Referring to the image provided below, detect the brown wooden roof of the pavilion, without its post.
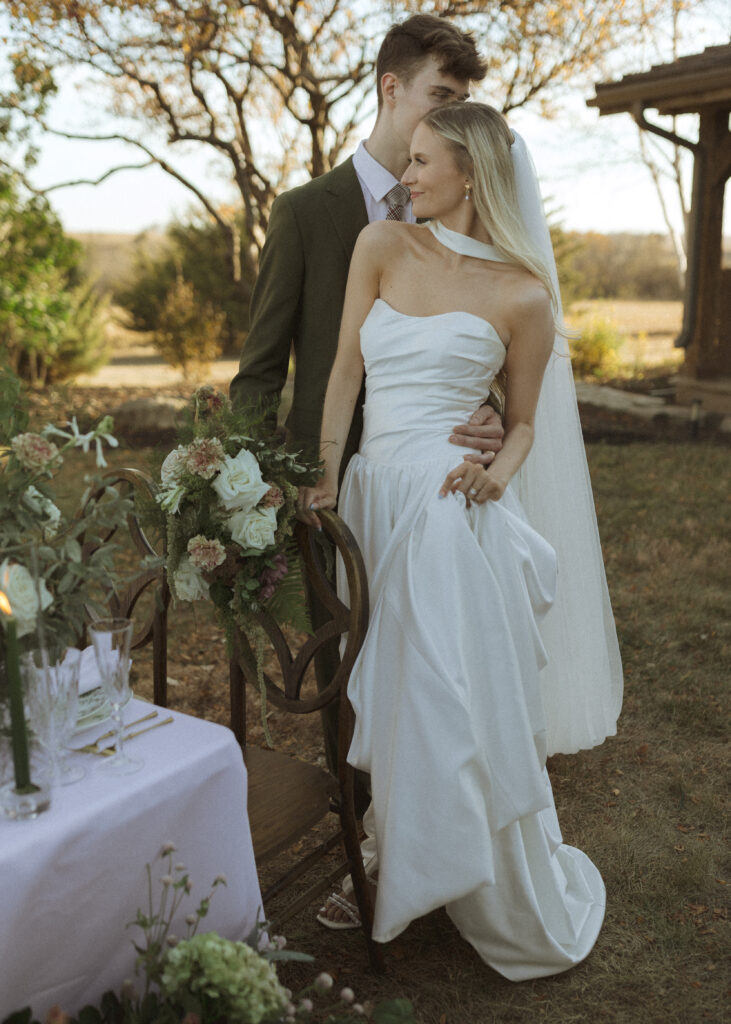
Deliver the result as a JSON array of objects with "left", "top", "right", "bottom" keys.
[{"left": 587, "top": 43, "right": 731, "bottom": 115}]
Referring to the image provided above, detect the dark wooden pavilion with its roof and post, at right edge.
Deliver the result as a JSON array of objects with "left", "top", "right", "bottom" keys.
[{"left": 587, "top": 43, "right": 731, "bottom": 412}]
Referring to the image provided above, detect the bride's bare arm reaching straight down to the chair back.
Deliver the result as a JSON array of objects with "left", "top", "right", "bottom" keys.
[{"left": 298, "top": 224, "right": 382, "bottom": 526}]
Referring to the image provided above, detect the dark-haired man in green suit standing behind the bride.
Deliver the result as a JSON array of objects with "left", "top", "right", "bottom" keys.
[{"left": 230, "top": 14, "right": 503, "bottom": 802}]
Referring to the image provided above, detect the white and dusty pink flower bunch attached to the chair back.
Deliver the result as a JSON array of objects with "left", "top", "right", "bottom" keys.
[{"left": 158, "top": 386, "right": 317, "bottom": 639}]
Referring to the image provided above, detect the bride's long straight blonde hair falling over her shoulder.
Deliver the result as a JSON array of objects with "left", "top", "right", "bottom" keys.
[{"left": 422, "top": 103, "right": 560, "bottom": 319}]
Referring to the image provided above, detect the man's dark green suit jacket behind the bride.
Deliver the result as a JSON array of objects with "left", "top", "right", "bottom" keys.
[{"left": 230, "top": 159, "right": 368, "bottom": 473}]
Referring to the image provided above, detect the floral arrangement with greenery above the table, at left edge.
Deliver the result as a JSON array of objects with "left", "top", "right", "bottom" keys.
[{"left": 0, "top": 371, "right": 130, "bottom": 664}]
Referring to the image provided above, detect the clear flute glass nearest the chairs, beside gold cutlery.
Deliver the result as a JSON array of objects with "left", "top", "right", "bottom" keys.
[{"left": 89, "top": 618, "right": 144, "bottom": 775}]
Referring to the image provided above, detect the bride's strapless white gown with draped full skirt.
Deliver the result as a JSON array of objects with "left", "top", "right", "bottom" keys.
[{"left": 339, "top": 299, "right": 605, "bottom": 981}]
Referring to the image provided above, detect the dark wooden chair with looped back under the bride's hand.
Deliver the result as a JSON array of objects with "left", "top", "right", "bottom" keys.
[{"left": 230, "top": 512, "right": 384, "bottom": 971}]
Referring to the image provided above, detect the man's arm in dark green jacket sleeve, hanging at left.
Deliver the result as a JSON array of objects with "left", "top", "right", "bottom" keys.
[{"left": 230, "top": 193, "right": 304, "bottom": 431}]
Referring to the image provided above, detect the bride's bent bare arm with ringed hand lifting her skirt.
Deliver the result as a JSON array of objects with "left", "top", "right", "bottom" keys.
[{"left": 439, "top": 282, "right": 555, "bottom": 504}]
